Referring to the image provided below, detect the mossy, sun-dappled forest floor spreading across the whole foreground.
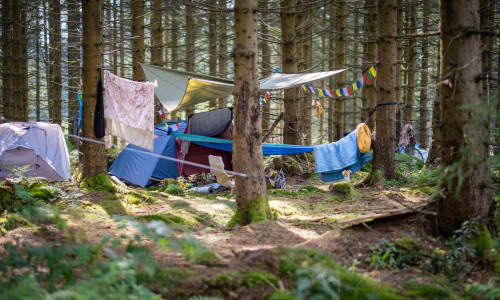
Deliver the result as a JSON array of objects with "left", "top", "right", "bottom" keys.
[{"left": 0, "top": 156, "right": 500, "bottom": 299}]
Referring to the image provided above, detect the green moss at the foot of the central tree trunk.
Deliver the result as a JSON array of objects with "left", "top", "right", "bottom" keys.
[{"left": 227, "top": 196, "right": 272, "bottom": 227}]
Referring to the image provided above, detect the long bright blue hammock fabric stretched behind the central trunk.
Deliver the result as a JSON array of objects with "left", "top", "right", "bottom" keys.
[{"left": 172, "top": 131, "right": 313, "bottom": 155}]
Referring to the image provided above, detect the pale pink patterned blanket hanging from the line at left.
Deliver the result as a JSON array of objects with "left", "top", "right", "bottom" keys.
[{"left": 104, "top": 71, "right": 154, "bottom": 151}]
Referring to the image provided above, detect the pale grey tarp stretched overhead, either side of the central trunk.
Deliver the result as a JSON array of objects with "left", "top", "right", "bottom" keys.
[{"left": 141, "top": 64, "right": 346, "bottom": 112}]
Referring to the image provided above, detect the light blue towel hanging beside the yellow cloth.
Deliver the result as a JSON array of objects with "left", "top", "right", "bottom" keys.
[{"left": 313, "top": 130, "right": 372, "bottom": 182}]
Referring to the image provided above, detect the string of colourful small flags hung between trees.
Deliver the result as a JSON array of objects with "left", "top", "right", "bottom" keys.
[{"left": 260, "top": 66, "right": 377, "bottom": 106}]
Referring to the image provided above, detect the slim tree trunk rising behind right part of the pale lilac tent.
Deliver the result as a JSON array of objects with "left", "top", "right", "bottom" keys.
[{"left": 49, "top": 0, "right": 62, "bottom": 125}]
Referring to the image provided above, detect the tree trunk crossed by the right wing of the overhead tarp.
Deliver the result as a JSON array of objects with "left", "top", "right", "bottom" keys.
[{"left": 280, "top": 0, "right": 302, "bottom": 145}]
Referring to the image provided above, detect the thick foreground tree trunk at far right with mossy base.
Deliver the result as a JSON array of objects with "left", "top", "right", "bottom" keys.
[{"left": 437, "top": 0, "right": 493, "bottom": 236}]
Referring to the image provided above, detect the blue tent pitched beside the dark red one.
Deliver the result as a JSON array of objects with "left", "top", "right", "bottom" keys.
[{"left": 109, "top": 121, "right": 187, "bottom": 187}]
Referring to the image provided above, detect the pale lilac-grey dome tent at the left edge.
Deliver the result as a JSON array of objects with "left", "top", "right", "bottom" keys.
[{"left": 0, "top": 122, "right": 71, "bottom": 180}]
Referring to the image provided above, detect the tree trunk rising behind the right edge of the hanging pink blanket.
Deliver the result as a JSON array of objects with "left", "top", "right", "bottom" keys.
[{"left": 132, "top": 0, "right": 146, "bottom": 81}]
